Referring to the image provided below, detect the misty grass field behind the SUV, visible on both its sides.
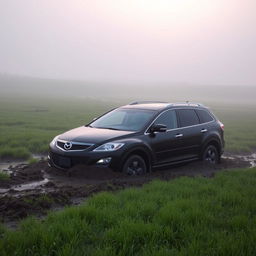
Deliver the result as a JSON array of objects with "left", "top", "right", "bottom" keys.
[{"left": 0, "top": 96, "right": 256, "bottom": 158}]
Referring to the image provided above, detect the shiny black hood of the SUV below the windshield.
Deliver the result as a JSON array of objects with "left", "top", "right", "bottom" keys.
[{"left": 58, "top": 126, "right": 134, "bottom": 144}]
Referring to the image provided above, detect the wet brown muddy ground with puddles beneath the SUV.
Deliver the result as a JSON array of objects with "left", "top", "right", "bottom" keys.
[{"left": 0, "top": 154, "right": 255, "bottom": 227}]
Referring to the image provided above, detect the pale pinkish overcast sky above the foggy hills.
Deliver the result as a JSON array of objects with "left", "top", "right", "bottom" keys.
[{"left": 0, "top": 0, "right": 256, "bottom": 86}]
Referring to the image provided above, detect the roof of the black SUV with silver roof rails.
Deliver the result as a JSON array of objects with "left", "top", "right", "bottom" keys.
[{"left": 121, "top": 101, "right": 205, "bottom": 110}]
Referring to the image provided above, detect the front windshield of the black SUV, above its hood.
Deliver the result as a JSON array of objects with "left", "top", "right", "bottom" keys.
[{"left": 89, "top": 109, "right": 155, "bottom": 131}]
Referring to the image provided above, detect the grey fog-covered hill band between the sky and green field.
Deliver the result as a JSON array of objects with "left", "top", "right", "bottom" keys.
[{"left": 0, "top": 75, "right": 256, "bottom": 109}]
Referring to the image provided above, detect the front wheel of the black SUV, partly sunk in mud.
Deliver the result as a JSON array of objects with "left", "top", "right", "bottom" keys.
[{"left": 122, "top": 155, "right": 147, "bottom": 175}]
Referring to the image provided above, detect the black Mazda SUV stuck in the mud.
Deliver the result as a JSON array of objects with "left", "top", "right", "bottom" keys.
[{"left": 48, "top": 102, "right": 224, "bottom": 174}]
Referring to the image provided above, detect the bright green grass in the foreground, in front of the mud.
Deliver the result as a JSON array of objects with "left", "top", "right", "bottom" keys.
[{"left": 0, "top": 168, "right": 256, "bottom": 256}]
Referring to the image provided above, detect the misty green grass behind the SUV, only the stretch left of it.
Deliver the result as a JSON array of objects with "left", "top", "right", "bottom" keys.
[{"left": 0, "top": 99, "right": 116, "bottom": 159}]
